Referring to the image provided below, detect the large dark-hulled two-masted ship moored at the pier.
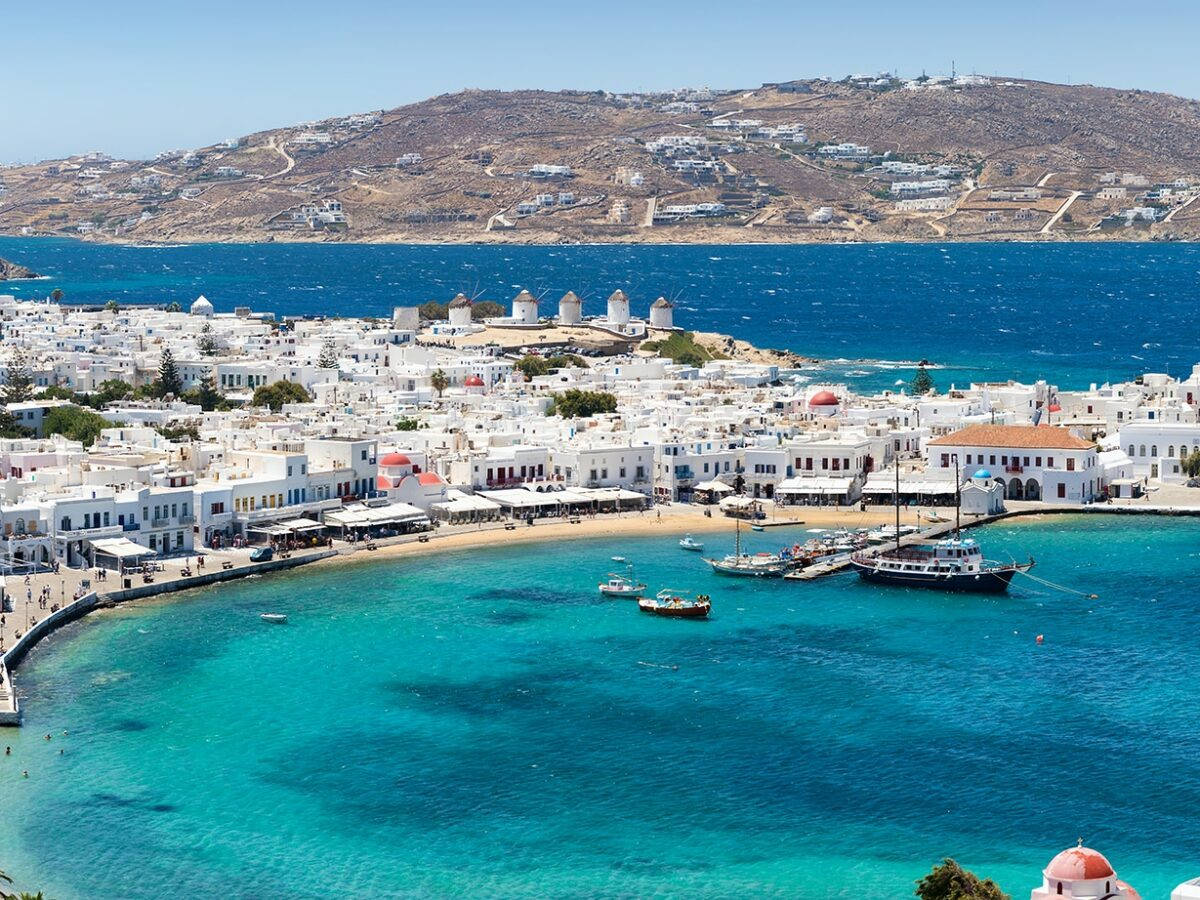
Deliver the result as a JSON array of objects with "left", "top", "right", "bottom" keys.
[{"left": 850, "top": 464, "right": 1033, "bottom": 594}]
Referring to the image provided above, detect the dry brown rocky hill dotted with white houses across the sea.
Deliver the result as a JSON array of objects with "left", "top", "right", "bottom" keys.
[{"left": 7, "top": 77, "right": 1200, "bottom": 244}]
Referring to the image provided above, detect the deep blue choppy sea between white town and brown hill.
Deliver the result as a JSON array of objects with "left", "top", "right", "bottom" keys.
[{"left": 0, "top": 238, "right": 1200, "bottom": 389}]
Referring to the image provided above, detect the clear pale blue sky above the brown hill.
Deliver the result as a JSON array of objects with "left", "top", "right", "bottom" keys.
[{"left": 9, "top": 0, "right": 1200, "bottom": 162}]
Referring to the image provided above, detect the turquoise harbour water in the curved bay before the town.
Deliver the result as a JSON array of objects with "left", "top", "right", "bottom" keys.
[{"left": 0, "top": 516, "right": 1200, "bottom": 899}]
